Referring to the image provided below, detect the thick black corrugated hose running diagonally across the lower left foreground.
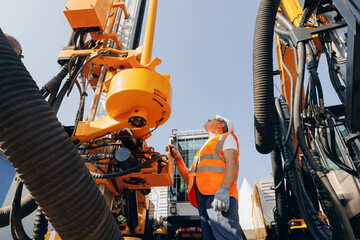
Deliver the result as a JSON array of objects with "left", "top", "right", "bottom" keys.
[{"left": 0, "top": 29, "right": 123, "bottom": 240}]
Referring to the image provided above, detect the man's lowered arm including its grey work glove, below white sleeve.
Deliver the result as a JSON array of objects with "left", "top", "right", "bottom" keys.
[{"left": 211, "top": 149, "right": 237, "bottom": 212}]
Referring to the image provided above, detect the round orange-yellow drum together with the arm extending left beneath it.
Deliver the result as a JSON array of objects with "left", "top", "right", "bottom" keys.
[{"left": 75, "top": 68, "right": 172, "bottom": 142}]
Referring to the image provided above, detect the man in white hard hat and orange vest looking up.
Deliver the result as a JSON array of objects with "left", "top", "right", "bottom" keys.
[{"left": 170, "top": 115, "right": 244, "bottom": 240}]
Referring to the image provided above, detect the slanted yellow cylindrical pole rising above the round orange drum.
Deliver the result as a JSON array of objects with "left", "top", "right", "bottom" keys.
[{"left": 141, "top": 0, "right": 158, "bottom": 65}]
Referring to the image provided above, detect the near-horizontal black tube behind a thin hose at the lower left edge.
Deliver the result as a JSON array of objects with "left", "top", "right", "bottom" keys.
[{"left": 0, "top": 194, "right": 37, "bottom": 228}]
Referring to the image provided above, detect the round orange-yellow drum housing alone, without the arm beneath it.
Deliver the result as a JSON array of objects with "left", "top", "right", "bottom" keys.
[{"left": 106, "top": 68, "right": 172, "bottom": 128}]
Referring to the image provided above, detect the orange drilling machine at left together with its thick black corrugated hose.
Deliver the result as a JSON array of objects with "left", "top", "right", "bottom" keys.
[{"left": 0, "top": 0, "right": 174, "bottom": 240}]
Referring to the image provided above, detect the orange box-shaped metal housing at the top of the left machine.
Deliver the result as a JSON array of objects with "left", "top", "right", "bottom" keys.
[{"left": 64, "top": 0, "right": 113, "bottom": 31}]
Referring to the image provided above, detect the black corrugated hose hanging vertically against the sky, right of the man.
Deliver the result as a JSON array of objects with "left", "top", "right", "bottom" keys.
[{"left": 253, "top": 0, "right": 280, "bottom": 154}]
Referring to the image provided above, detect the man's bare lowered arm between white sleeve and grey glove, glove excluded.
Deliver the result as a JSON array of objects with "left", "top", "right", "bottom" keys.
[{"left": 221, "top": 149, "right": 238, "bottom": 189}]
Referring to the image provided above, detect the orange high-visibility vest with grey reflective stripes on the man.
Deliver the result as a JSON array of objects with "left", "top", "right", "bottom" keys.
[{"left": 188, "top": 132, "right": 239, "bottom": 208}]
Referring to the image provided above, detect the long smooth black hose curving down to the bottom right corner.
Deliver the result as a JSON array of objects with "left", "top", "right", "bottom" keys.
[{"left": 294, "top": 42, "right": 355, "bottom": 240}]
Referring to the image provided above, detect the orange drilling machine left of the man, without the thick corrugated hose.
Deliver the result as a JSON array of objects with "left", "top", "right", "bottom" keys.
[{"left": 59, "top": 0, "right": 173, "bottom": 238}]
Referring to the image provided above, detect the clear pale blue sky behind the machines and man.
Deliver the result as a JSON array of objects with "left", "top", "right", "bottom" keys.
[{"left": 0, "top": 0, "right": 282, "bottom": 239}]
